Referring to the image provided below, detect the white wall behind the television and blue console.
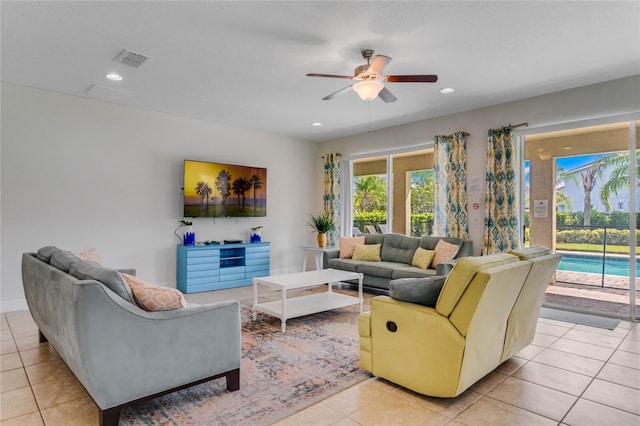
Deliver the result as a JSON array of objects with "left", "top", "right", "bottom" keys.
[{"left": 0, "top": 83, "right": 322, "bottom": 311}]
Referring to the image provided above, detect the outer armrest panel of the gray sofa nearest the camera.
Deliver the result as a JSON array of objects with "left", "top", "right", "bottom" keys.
[{"left": 69, "top": 281, "right": 241, "bottom": 409}]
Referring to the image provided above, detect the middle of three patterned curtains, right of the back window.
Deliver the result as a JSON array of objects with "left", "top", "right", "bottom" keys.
[{"left": 433, "top": 132, "right": 469, "bottom": 240}]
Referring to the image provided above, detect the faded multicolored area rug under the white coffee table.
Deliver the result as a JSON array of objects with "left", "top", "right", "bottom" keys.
[{"left": 120, "top": 288, "right": 371, "bottom": 426}]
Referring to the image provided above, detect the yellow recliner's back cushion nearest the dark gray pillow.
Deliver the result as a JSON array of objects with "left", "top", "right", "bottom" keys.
[{"left": 436, "top": 253, "right": 518, "bottom": 317}]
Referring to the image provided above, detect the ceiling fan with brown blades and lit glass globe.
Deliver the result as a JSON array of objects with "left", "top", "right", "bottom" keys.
[{"left": 307, "top": 49, "right": 438, "bottom": 103}]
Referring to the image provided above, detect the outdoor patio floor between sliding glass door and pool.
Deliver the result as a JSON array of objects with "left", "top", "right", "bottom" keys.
[{"left": 544, "top": 270, "right": 640, "bottom": 319}]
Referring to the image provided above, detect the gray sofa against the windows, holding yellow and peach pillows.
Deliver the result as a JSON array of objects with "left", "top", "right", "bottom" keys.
[{"left": 323, "top": 234, "right": 473, "bottom": 290}]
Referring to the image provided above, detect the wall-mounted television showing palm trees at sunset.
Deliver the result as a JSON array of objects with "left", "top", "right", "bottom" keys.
[{"left": 183, "top": 160, "right": 267, "bottom": 217}]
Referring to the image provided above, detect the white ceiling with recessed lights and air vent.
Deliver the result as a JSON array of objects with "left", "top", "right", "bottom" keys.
[{"left": 0, "top": 0, "right": 640, "bottom": 141}]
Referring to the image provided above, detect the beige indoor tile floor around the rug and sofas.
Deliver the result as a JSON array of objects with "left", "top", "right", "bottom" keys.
[{"left": 0, "top": 289, "right": 640, "bottom": 426}]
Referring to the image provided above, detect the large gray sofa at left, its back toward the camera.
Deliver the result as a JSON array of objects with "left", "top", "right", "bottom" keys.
[{"left": 22, "top": 251, "right": 241, "bottom": 425}]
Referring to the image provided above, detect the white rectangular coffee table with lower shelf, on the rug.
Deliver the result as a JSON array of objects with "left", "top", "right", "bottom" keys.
[{"left": 253, "top": 269, "right": 363, "bottom": 333}]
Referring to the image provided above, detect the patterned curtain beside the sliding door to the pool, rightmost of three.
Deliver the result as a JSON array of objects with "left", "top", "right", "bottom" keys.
[{"left": 482, "top": 127, "right": 520, "bottom": 256}]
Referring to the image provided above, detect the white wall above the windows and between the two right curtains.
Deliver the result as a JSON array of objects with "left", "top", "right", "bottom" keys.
[{"left": 318, "top": 75, "right": 640, "bottom": 254}]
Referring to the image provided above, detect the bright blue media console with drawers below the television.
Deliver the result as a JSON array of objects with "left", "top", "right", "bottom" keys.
[{"left": 177, "top": 242, "right": 270, "bottom": 293}]
